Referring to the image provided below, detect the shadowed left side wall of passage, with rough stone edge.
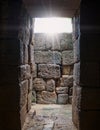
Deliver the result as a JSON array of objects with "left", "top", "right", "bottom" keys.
[{"left": 0, "top": 0, "right": 33, "bottom": 130}]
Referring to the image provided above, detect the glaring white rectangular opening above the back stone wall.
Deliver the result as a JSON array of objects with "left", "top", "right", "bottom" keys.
[{"left": 34, "top": 17, "right": 72, "bottom": 34}]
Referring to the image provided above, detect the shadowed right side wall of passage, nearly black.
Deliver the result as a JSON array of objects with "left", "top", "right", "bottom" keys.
[{"left": 72, "top": 0, "right": 100, "bottom": 130}]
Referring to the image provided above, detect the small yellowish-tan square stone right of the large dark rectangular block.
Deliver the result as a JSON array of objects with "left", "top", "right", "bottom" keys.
[{"left": 62, "top": 65, "right": 73, "bottom": 75}]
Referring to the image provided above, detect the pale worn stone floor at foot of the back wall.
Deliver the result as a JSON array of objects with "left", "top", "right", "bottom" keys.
[{"left": 23, "top": 104, "right": 76, "bottom": 130}]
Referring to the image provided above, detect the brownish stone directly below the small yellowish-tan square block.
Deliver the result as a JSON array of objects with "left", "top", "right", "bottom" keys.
[{"left": 60, "top": 75, "right": 73, "bottom": 87}]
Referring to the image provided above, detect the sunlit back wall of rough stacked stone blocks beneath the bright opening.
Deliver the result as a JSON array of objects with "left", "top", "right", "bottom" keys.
[{"left": 33, "top": 33, "right": 74, "bottom": 104}]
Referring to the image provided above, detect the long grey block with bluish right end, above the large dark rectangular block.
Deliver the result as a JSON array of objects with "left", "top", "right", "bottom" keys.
[{"left": 34, "top": 51, "right": 61, "bottom": 64}]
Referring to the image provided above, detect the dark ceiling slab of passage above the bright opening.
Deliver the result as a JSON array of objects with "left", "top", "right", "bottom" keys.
[{"left": 23, "top": 0, "right": 80, "bottom": 17}]
